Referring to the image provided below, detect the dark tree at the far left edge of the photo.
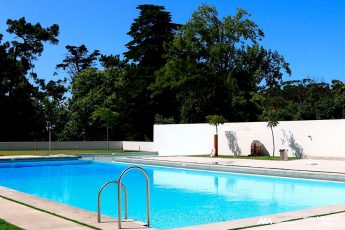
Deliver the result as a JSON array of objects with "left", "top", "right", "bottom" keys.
[{"left": 0, "top": 18, "right": 59, "bottom": 141}]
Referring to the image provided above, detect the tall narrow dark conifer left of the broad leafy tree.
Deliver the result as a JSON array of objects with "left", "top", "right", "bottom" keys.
[{"left": 124, "top": 4, "right": 179, "bottom": 139}]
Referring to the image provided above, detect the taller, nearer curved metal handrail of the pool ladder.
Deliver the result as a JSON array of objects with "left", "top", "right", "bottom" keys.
[{"left": 117, "top": 166, "right": 150, "bottom": 229}]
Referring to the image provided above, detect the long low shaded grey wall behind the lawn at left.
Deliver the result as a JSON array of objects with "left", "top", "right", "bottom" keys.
[{"left": 0, "top": 141, "right": 122, "bottom": 150}]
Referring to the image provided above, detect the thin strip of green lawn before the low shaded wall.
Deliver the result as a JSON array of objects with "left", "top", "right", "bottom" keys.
[{"left": 0, "top": 149, "right": 138, "bottom": 156}]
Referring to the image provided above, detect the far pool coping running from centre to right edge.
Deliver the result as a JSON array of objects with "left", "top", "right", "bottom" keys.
[{"left": 115, "top": 157, "right": 345, "bottom": 182}]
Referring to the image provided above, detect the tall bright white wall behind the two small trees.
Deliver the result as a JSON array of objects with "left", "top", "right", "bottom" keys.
[{"left": 154, "top": 119, "right": 345, "bottom": 157}]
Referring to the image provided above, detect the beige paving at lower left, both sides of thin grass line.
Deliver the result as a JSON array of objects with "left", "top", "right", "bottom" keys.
[{"left": 0, "top": 186, "right": 148, "bottom": 230}]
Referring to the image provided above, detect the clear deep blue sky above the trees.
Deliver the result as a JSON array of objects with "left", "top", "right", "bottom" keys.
[{"left": 0, "top": 0, "right": 345, "bottom": 82}]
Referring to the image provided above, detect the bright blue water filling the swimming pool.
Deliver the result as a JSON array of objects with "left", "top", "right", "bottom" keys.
[{"left": 0, "top": 160, "right": 345, "bottom": 229}]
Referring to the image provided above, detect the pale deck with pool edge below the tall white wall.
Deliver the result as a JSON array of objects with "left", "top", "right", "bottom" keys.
[{"left": 115, "top": 156, "right": 345, "bottom": 182}]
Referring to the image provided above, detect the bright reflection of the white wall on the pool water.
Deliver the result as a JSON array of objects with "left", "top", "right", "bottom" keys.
[{"left": 153, "top": 170, "right": 345, "bottom": 206}]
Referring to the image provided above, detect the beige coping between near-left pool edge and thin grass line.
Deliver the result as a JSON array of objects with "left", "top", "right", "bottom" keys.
[{"left": 0, "top": 186, "right": 150, "bottom": 230}]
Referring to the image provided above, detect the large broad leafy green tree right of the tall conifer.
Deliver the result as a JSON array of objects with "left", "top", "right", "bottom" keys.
[{"left": 153, "top": 5, "right": 290, "bottom": 123}]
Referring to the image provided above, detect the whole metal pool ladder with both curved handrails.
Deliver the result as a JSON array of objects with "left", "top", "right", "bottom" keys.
[{"left": 97, "top": 166, "right": 150, "bottom": 229}]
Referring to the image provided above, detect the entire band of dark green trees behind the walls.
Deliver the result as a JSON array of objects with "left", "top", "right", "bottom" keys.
[{"left": 0, "top": 4, "right": 345, "bottom": 141}]
